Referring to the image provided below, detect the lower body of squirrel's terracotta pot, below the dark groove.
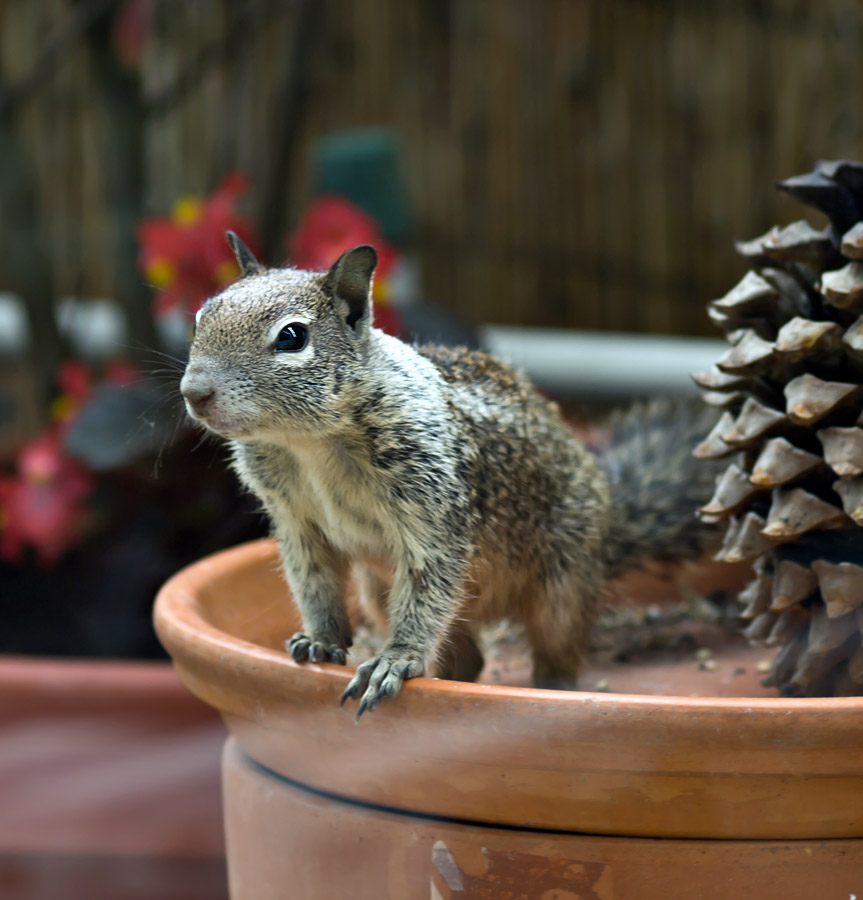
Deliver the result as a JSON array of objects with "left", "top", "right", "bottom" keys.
[{"left": 222, "top": 738, "right": 863, "bottom": 900}]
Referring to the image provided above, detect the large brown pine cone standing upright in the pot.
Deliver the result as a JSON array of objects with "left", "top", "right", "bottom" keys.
[{"left": 695, "top": 161, "right": 863, "bottom": 696}]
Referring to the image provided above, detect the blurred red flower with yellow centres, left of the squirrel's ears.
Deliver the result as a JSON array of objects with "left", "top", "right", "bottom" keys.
[{"left": 137, "top": 172, "right": 257, "bottom": 315}]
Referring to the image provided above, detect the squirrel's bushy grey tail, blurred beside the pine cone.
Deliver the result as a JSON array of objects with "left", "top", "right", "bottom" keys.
[{"left": 599, "top": 398, "right": 727, "bottom": 576}]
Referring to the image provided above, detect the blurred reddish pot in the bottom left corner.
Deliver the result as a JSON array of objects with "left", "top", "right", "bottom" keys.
[{"left": 0, "top": 656, "right": 226, "bottom": 900}]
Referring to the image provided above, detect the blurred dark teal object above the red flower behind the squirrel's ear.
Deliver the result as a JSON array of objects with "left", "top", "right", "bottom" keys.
[{"left": 311, "top": 129, "right": 410, "bottom": 245}]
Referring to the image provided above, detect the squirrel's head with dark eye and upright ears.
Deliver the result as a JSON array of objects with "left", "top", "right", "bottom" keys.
[{"left": 180, "top": 232, "right": 377, "bottom": 442}]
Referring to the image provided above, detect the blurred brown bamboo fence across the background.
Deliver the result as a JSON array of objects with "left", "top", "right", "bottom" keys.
[{"left": 0, "top": 0, "right": 863, "bottom": 341}]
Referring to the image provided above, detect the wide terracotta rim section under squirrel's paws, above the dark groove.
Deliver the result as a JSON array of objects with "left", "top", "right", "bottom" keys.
[{"left": 155, "top": 541, "right": 863, "bottom": 844}]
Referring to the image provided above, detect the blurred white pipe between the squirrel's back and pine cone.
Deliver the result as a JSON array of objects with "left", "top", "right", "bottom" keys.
[{"left": 479, "top": 325, "right": 728, "bottom": 397}]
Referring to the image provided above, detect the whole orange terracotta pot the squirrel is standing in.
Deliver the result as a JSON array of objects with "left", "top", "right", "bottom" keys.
[{"left": 156, "top": 541, "right": 863, "bottom": 900}]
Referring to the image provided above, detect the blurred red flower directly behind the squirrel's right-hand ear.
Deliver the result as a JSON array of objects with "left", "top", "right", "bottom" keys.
[{"left": 288, "top": 194, "right": 402, "bottom": 335}]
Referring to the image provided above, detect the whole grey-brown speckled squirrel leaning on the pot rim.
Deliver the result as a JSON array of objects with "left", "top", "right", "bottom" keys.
[{"left": 180, "top": 232, "right": 716, "bottom": 719}]
